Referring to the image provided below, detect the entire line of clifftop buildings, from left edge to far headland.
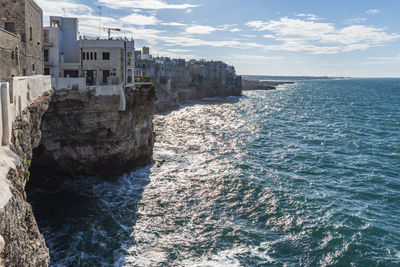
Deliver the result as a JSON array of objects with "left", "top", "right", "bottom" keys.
[{"left": 0, "top": 0, "right": 241, "bottom": 112}]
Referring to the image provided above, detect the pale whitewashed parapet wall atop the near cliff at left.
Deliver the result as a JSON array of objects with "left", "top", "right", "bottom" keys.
[{"left": 0, "top": 75, "right": 51, "bottom": 145}]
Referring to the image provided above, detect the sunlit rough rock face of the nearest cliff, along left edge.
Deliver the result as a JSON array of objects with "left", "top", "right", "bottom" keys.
[{"left": 0, "top": 93, "right": 51, "bottom": 266}]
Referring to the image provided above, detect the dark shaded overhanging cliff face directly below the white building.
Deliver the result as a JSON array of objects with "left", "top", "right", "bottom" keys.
[{"left": 32, "top": 89, "right": 154, "bottom": 178}]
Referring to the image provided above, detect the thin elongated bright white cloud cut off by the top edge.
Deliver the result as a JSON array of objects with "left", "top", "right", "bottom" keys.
[{"left": 95, "top": 0, "right": 199, "bottom": 9}]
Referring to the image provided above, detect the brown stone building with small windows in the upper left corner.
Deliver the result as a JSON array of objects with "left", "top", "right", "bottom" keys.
[{"left": 0, "top": 0, "right": 43, "bottom": 78}]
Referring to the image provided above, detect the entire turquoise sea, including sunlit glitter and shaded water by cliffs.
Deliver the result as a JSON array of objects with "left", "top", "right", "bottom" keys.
[{"left": 30, "top": 79, "right": 400, "bottom": 266}]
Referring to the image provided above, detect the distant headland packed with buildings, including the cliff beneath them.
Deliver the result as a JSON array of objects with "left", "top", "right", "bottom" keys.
[{"left": 135, "top": 47, "right": 242, "bottom": 110}]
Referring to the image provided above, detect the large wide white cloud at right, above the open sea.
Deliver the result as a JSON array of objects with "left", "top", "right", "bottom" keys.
[{"left": 246, "top": 17, "right": 400, "bottom": 54}]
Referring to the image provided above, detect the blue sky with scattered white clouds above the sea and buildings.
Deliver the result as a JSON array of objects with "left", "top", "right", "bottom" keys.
[{"left": 35, "top": 0, "right": 400, "bottom": 77}]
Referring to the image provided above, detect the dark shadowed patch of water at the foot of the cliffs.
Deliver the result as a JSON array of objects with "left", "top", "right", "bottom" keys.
[{"left": 27, "top": 166, "right": 152, "bottom": 266}]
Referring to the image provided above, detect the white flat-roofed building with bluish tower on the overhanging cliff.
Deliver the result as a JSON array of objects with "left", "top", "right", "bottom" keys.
[{"left": 44, "top": 17, "right": 135, "bottom": 87}]
